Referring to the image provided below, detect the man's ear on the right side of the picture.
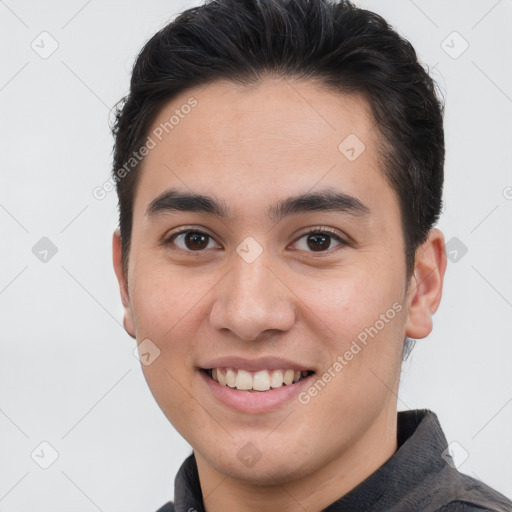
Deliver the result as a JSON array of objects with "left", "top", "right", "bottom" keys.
[{"left": 405, "top": 229, "right": 447, "bottom": 339}]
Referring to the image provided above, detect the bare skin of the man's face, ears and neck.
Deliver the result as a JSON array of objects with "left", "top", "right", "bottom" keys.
[{"left": 113, "top": 77, "right": 446, "bottom": 512}]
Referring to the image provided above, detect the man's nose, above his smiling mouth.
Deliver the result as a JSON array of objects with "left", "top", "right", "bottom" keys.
[{"left": 210, "top": 251, "right": 296, "bottom": 341}]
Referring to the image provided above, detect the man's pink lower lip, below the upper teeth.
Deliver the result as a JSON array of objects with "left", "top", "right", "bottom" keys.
[{"left": 199, "top": 370, "right": 315, "bottom": 414}]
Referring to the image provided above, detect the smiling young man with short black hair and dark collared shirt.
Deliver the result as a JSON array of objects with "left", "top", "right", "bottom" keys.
[{"left": 113, "top": 0, "right": 512, "bottom": 512}]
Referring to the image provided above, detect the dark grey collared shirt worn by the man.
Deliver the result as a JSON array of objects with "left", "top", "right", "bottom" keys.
[{"left": 157, "top": 409, "right": 512, "bottom": 512}]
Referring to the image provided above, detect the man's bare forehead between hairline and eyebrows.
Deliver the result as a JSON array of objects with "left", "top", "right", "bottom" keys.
[{"left": 134, "top": 78, "right": 394, "bottom": 220}]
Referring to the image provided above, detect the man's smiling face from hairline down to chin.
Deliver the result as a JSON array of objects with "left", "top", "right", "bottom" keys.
[{"left": 114, "top": 78, "right": 446, "bottom": 484}]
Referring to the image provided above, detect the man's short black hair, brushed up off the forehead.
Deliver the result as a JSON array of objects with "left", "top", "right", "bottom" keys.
[{"left": 112, "top": 0, "right": 445, "bottom": 356}]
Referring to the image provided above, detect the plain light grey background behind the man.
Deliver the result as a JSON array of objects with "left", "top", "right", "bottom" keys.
[{"left": 0, "top": 0, "right": 512, "bottom": 512}]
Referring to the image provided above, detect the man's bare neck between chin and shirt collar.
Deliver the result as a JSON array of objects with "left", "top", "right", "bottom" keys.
[{"left": 195, "top": 409, "right": 397, "bottom": 512}]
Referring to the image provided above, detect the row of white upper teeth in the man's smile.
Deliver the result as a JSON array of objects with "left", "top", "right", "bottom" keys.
[{"left": 210, "top": 368, "right": 308, "bottom": 391}]
